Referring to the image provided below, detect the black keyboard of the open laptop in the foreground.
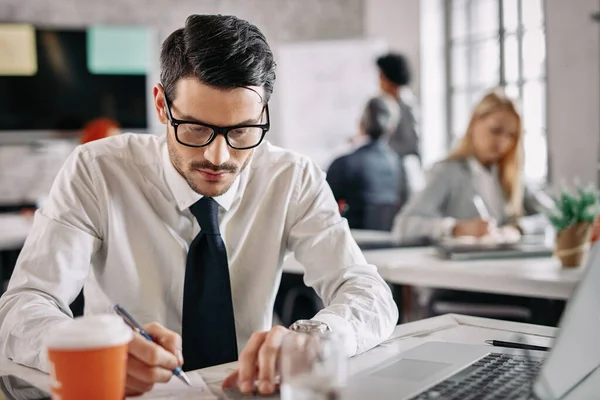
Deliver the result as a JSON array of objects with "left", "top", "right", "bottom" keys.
[{"left": 412, "top": 353, "right": 543, "bottom": 400}]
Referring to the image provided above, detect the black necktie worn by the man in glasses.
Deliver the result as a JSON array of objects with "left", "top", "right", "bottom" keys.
[{"left": 181, "top": 197, "right": 238, "bottom": 371}]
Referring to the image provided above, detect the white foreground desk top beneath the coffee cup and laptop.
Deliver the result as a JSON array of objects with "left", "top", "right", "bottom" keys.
[{"left": 0, "top": 314, "right": 600, "bottom": 399}]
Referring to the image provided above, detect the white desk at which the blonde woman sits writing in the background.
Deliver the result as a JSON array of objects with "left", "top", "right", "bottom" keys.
[{"left": 283, "top": 247, "right": 583, "bottom": 300}]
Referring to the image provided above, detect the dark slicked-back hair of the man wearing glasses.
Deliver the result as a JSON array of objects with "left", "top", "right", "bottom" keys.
[{"left": 160, "top": 14, "right": 275, "bottom": 103}]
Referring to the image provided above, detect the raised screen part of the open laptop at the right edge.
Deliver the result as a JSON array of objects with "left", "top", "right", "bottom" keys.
[{"left": 534, "top": 244, "right": 600, "bottom": 399}]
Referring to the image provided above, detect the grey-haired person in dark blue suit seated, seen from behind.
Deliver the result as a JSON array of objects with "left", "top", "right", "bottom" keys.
[{"left": 327, "top": 95, "right": 408, "bottom": 230}]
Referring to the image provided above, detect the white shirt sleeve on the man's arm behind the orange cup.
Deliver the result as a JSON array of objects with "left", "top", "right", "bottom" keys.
[{"left": 0, "top": 148, "right": 101, "bottom": 372}]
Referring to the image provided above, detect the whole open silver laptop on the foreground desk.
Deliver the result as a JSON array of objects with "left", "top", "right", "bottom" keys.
[{"left": 346, "top": 245, "right": 600, "bottom": 400}]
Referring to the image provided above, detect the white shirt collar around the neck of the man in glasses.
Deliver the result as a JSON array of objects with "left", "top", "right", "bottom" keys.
[{"left": 161, "top": 140, "right": 240, "bottom": 211}]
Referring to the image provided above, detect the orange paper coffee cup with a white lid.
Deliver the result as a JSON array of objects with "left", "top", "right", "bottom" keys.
[{"left": 46, "top": 315, "right": 132, "bottom": 400}]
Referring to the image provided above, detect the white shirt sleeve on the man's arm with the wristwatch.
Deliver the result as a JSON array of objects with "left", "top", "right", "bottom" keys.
[{"left": 288, "top": 158, "right": 398, "bottom": 356}]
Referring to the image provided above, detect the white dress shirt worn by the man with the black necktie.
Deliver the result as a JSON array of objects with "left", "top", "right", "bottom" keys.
[{"left": 0, "top": 134, "right": 398, "bottom": 371}]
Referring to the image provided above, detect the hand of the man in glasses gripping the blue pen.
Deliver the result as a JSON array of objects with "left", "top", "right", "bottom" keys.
[{"left": 125, "top": 322, "right": 183, "bottom": 396}]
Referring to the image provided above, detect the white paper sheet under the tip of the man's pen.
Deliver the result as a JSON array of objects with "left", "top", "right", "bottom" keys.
[{"left": 128, "top": 371, "right": 218, "bottom": 400}]
